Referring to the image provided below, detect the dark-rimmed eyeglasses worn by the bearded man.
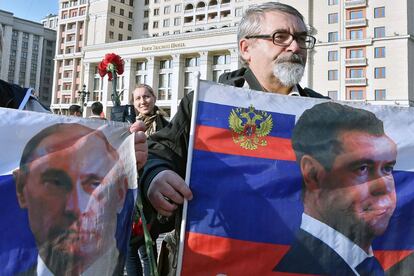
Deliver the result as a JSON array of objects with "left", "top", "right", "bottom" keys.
[{"left": 245, "top": 31, "right": 316, "bottom": 49}]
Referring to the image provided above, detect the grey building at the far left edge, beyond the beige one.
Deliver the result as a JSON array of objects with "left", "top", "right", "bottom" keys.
[{"left": 0, "top": 10, "right": 56, "bottom": 106}]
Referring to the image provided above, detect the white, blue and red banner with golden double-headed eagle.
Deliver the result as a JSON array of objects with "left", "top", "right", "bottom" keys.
[{"left": 179, "top": 81, "right": 414, "bottom": 275}]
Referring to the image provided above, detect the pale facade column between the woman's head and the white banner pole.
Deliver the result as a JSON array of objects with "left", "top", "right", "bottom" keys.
[{"left": 171, "top": 54, "right": 184, "bottom": 118}]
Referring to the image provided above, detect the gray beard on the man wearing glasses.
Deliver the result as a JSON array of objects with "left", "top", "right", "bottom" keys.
[{"left": 273, "top": 62, "right": 305, "bottom": 87}]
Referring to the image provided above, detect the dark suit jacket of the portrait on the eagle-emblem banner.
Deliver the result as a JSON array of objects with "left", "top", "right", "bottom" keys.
[{"left": 273, "top": 229, "right": 355, "bottom": 276}]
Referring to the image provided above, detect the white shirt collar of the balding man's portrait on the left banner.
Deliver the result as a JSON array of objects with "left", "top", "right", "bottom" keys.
[{"left": 36, "top": 239, "right": 119, "bottom": 276}]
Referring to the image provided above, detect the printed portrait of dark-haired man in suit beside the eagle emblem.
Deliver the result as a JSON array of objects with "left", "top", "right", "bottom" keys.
[{"left": 274, "top": 102, "right": 397, "bottom": 275}]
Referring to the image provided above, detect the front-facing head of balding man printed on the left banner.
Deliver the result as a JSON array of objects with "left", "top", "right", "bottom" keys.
[{"left": 14, "top": 123, "right": 128, "bottom": 275}]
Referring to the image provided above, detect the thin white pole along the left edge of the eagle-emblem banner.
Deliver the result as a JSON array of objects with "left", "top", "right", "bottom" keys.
[{"left": 176, "top": 71, "right": 200, "bottom": 275}]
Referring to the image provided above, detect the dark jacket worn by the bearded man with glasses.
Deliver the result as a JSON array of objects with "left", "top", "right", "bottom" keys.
[{"left": 139, "top": 68, "right": 327, "bottom": 224}]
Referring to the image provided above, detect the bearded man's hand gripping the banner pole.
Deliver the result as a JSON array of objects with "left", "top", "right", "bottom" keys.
[{"left": 147, "top": 170, "right": 193, "bottom": 217}]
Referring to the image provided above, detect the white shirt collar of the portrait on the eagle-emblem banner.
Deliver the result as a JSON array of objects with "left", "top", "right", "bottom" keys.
[{"left": 300, "top": 213, "right": 374, "bottom": 275}]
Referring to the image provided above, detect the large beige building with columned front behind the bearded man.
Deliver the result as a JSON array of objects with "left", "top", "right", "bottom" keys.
[{"left": 52, "top": 0, "right": 414, "bottom": 115}]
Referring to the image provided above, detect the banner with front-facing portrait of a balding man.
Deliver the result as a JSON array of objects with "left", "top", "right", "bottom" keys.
[{"left": 0, "top": 108, "right": 137, "bottom": 275}]
